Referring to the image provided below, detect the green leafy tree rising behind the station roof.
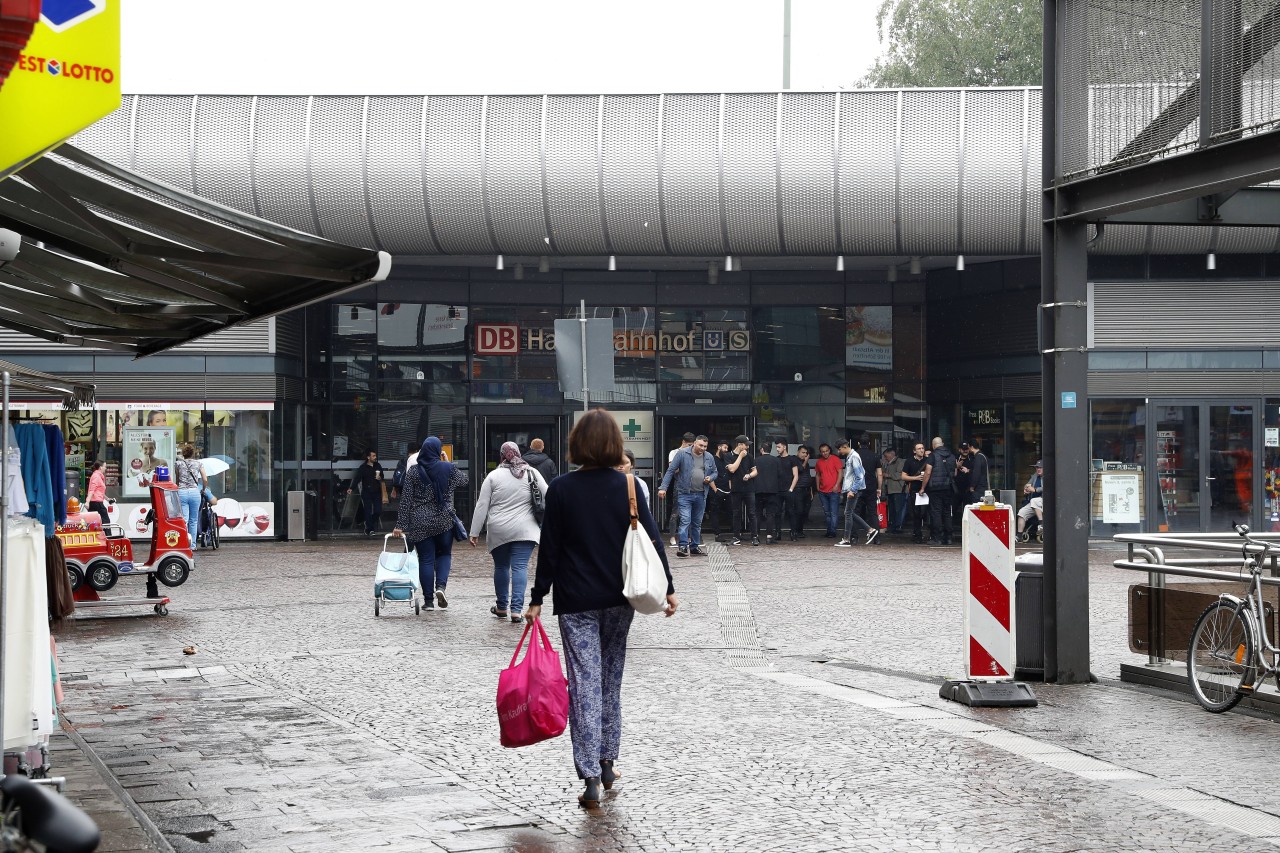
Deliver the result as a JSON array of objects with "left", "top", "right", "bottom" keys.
[{"left": 860, "top": 0, "right": 1042, "bottom": 88}]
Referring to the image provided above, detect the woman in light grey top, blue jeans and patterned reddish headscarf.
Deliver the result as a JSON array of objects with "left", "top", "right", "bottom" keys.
[{"left": 471, "top": 442, "right": 547, "bottom": 622}]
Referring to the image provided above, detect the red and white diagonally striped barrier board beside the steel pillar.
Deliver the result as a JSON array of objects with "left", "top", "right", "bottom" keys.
[{"left": 961, "top": 503, "right": 1016, "bottom": 681}]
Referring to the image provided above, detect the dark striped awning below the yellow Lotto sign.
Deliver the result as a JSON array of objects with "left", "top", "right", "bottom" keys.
[{"left": 0, "top": 145, "right": 392, "bottom": 356}]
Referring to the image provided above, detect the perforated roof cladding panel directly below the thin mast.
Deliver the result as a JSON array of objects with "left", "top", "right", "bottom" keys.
[{"left": 778, "top": 92, "right": 840, "bottom": 255}]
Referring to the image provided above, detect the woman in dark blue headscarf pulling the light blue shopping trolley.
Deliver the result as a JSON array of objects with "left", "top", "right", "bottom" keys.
[{"left": 392, "top": 435, "right": 467, "bottom": 610}]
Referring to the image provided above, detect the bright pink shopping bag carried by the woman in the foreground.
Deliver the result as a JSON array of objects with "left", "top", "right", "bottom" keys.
[{"left": 498, "top": 619, "right": 568, "bottom": 747}]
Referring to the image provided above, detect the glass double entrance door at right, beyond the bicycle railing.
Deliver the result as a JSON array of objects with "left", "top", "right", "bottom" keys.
[{"left": 1152, "top": 401, "right": 1260, "bottom": 533}]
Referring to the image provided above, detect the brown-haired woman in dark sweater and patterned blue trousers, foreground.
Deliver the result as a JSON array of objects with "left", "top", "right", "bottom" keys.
[{"left": 525, "top": 409, "right": 680, "bottom": 808}]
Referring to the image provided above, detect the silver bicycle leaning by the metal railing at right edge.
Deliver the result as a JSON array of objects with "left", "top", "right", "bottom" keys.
[{"left": 1187, "top": 524, "right": 1280, "bottom": 713}]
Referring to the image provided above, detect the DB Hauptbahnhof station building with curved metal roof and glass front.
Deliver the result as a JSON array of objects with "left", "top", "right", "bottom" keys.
[{"left": 0, "top": 88, "right": 1280, "bottom": 537}]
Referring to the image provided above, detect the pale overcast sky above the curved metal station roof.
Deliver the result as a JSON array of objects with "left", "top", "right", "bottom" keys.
[{"left": 119, "top": 0, "right": 879, "bottom": 95}]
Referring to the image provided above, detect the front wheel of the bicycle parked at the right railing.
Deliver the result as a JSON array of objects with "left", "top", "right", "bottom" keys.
[{"left": 1187, "top": 601, "right": 1254, "bottom": 713}]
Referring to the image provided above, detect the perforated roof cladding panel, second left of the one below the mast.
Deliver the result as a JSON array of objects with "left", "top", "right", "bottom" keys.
[{"left": 662, "top": 95, "right": 726, "bottom": 255}]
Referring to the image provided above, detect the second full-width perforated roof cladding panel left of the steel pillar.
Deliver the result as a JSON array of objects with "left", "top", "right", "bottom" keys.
[{"left": 900, "top": 90, "right": 960, "bottom": 255}]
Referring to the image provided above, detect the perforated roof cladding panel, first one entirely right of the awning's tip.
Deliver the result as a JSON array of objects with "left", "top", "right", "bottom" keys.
[{"left": 425, "top": 96, "right": 494, "bottom": 255}]
